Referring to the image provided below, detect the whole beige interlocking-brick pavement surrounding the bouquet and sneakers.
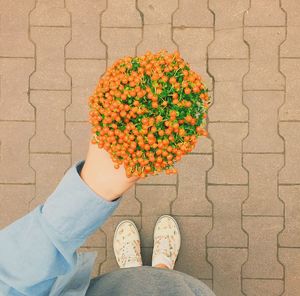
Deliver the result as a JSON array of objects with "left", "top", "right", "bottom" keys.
[{"left": 0, "top": 0, "right": 300, "bottom": 296}]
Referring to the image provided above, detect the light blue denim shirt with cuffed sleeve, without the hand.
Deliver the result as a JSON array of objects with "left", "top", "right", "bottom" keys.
[{"left": 0, "top": 160, "right": 121, "bottom": 296}]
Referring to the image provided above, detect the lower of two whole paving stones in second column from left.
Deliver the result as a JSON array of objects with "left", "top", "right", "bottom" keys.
[{"left": 30, "top": 90, "right": 71, "bottom": 153}]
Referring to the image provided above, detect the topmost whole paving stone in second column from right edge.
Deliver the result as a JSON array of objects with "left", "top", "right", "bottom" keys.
[{"left": 244, "top": 27, "right": 285, "bottom": 90}]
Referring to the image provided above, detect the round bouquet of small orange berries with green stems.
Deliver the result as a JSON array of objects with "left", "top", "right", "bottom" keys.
[{"left": 89, "top": 50, "right": 210, "bottom": 178}]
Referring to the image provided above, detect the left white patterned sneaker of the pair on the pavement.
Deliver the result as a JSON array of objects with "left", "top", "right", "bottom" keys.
[{"left": 113, "top": 220, "right": 143, "bottom": 268}]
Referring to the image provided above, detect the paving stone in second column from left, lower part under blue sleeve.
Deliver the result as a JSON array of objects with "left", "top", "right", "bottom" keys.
[{"left": 30, "top": 153, "right": 71, "bottom": 210}]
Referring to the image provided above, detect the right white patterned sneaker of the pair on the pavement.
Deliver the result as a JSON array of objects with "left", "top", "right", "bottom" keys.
[{"left": 152, "top": 215, "right": 181, "bottom": 269}]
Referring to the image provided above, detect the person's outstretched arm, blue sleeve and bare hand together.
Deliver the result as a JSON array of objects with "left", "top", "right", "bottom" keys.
[{"left": 0, "top": 136, "right": 137, "bottom": 296}]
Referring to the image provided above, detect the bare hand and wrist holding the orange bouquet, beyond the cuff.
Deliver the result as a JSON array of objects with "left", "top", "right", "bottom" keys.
[{"left": 80, "top": 134, "right": 140, "bottom": 201}]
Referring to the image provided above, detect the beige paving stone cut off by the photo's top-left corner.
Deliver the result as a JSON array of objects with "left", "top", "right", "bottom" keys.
[{"left": 0, "top": 0, "right": 35, "bottom": 57}]
